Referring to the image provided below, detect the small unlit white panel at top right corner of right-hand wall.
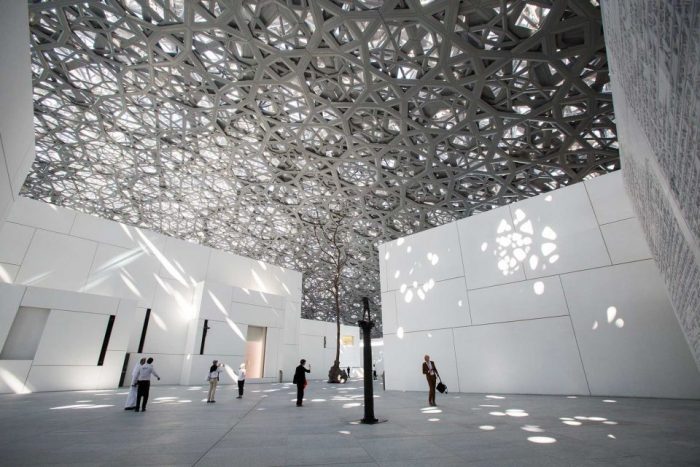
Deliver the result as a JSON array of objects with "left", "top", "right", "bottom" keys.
[{"left": 584, "top": 171, "right": 635, "bottom": 224}]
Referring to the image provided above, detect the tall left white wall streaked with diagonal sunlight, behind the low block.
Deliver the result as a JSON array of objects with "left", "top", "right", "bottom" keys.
[{"left": 0, "top": 198, "right": 301, "bottom": 387}]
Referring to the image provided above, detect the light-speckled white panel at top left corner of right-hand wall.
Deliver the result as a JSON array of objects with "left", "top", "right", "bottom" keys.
[{"left": 385, "top": 223, "right": 464, "bottom": 290}]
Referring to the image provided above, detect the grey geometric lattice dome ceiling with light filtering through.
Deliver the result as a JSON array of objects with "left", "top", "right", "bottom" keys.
[{"left": 23, "top": 0, "right": 619, "bottom": 330}]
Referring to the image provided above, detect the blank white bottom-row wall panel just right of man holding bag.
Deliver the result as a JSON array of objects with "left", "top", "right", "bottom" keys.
[{"left": 454, "top": 316, "right": 588, "bottom": 394}]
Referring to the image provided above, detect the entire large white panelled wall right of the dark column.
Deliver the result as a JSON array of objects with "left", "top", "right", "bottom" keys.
[{"left": 379, "top": 172, "right": 700, "bottom": 398}]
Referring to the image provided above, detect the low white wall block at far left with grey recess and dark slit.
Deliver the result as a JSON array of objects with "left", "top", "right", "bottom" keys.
[{"left": 0, "top": 284, "right": 136, "bottom": 394}]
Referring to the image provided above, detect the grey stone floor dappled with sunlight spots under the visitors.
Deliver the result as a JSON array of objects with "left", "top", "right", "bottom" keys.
[{"left": 0, "top": 381, "right": 700, "bottom": 467}]
